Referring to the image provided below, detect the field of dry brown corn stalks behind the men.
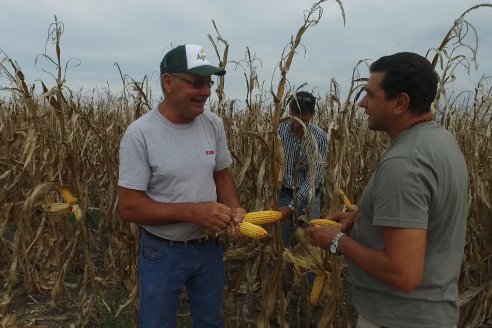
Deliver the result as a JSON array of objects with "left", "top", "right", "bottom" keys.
[{"left": 0, "top": 1, "right": 492, "bottom": 328}]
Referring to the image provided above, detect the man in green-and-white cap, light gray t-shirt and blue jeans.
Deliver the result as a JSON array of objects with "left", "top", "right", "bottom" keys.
[{"left": 118, "top": 45, "right": 246, "bottom": 328}]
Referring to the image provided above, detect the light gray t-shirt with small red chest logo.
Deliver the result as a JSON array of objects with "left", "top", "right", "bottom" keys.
[{"left": 118, "top": 108, "right": 232, "bottom": 240}]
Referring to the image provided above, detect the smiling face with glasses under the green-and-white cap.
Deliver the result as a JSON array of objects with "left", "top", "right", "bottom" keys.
[{"left": 161, "top": 73, "right": 213, "bottom": 124}]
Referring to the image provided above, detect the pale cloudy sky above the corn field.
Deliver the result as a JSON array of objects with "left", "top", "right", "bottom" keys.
[{"left": 0, "top": 0, "right": 492, "bottom": 103}]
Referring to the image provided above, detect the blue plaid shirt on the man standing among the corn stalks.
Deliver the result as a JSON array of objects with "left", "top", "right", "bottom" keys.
[{"left": 278, "top": 122, "right": 328, "bottom": 208}]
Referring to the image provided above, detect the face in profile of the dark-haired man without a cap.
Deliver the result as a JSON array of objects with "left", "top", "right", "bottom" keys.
[{"left": 359, "top": 72, "right": 397, "bottom": 132}]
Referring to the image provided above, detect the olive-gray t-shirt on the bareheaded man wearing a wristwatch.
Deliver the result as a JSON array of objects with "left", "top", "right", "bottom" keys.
[{"left": 350, "top": 122, "right": 468, "bottom": 328}]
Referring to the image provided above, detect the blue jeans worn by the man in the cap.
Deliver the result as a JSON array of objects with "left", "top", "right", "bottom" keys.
[{"left": 138, "top": 233, "right": 225, "bottom": 328}]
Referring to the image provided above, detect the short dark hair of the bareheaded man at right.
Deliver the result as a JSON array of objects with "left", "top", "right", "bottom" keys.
[{"left": 369, "top": 52, "right": 438, "bottom": 114}]
